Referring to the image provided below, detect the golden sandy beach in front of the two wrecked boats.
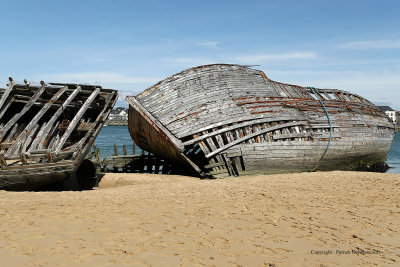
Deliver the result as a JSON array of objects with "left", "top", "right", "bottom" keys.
[{"left": 0, "top": 172, "right": 400, "bottom": 266}]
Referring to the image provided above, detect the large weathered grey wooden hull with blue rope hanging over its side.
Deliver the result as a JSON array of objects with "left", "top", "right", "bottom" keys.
[{"left": 127, "top": 64, "right": 394, "bottom": 177}]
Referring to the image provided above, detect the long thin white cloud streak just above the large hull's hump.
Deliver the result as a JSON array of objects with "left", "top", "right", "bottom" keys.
[{"left": 236, "top": 52, "right": 316, "bottom": 64}]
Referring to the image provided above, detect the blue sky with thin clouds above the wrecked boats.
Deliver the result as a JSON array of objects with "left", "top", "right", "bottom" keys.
[{"left": 0, "top": 0, "right": 400, "bottom": 110}]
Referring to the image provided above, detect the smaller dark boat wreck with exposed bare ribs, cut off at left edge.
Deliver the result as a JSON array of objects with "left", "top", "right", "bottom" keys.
[{"left": 0, "top": 78, "right": 118, "bottom": 190}]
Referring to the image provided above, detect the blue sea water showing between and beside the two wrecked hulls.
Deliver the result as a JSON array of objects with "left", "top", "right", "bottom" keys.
[{"left": 96, "top": 126, "right": 400, "bottom": 176}]
